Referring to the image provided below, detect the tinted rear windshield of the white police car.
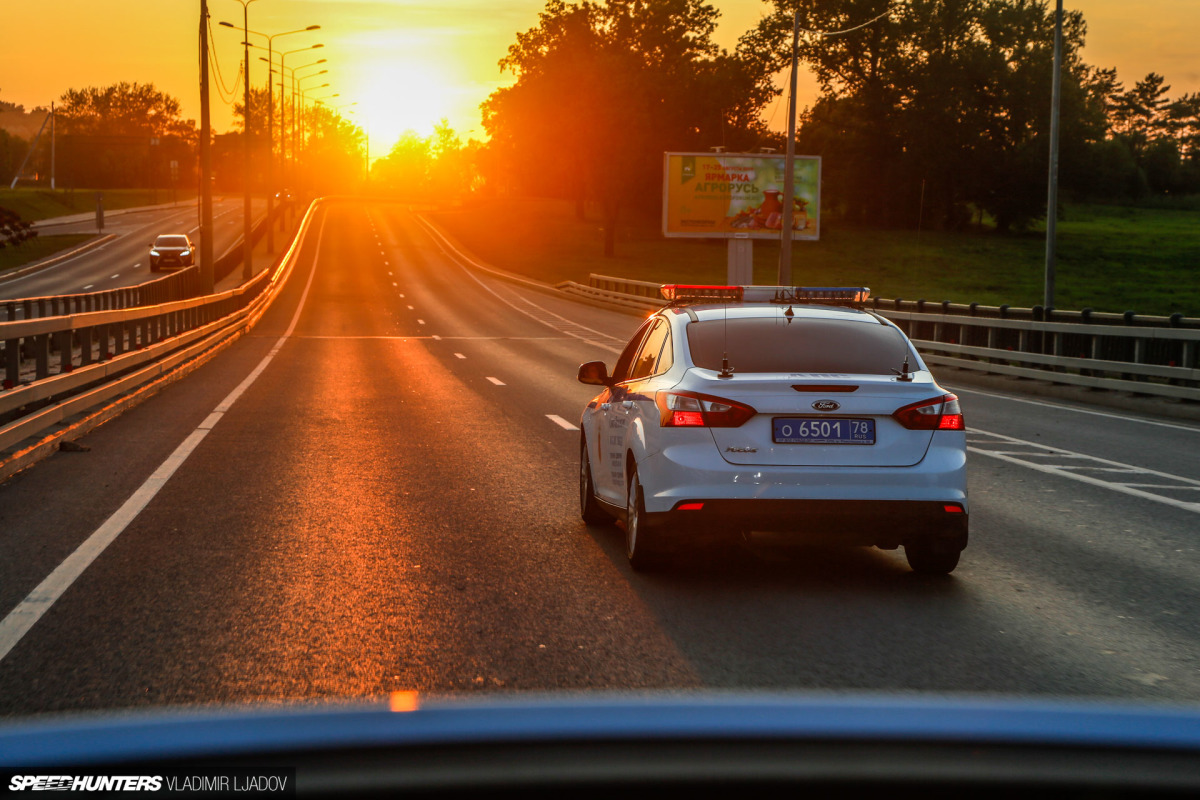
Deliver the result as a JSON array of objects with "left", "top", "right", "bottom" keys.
[{"left": 686, "top": 318, "right": 916, "bottom": 375}]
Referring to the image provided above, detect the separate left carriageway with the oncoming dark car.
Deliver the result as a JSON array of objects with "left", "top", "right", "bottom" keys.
[{"left": 0, "top": 197, "right": 266, "bottom": 300}]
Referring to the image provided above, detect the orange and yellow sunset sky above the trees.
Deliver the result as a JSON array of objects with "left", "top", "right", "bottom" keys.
[{"left": 0, "top": 0, "right": 1200, "bottom": 157}]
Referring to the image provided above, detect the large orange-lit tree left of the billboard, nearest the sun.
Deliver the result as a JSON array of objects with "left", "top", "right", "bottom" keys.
[{"left": 484, "top": 0, "right": 774, "bottom": 255}]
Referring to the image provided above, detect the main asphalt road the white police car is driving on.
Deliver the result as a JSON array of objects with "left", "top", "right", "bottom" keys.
[{"left": 0, "top": 196, "right": 1200, "bottom": 715}]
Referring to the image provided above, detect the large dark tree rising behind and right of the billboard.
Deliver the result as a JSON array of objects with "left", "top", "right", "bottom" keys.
[{"left": 743, "top": 0, "right": 1104, "bottom": 229}]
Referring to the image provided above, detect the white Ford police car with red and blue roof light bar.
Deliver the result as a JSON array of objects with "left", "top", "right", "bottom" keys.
[{"left": 578, "top": 285, "right": 968, "bottom": 573}]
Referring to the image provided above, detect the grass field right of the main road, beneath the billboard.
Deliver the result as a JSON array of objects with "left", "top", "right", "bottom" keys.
[{"left": 431, "top": 198, "right": 1200, "bottom": 317}]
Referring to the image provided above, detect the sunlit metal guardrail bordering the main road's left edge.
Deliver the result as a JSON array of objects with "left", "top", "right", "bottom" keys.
[{"left": 0, "top": 203, "right": 317, "bottom": 467}]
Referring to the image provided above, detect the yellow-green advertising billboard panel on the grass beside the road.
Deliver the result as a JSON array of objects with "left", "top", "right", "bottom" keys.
[{"left": 662, "top": 152, "right": 821, "bottom": 240}]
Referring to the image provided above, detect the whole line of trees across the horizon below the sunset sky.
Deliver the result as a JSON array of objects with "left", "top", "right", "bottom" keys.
[{"left": 0, "top": 0, "right": 1200, "bottom": 247}]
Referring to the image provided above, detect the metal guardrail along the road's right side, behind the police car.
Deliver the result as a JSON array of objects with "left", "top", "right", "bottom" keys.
[{"left": 573, "top": 275, "right": 1200, "bottom": 402}]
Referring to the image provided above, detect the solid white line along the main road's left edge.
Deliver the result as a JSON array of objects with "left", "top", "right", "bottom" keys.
[{"left": 0, "top": 212, "right": 325, "bottom": 661}]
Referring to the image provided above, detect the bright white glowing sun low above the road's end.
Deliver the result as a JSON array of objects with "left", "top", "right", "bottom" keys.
[{"left": 358, "top": 64, "right": 454, "bottom": 150}]
